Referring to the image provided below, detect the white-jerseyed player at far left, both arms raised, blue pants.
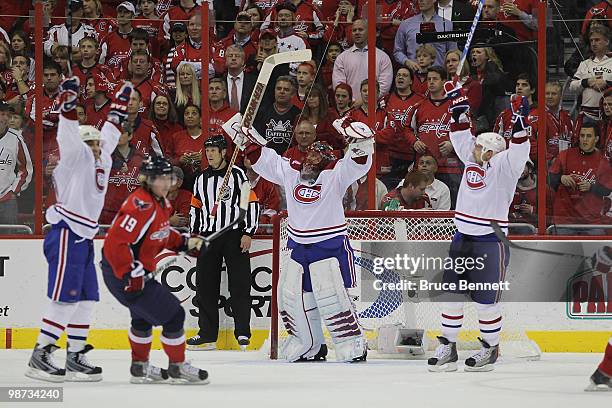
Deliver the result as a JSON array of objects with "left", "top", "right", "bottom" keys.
[{"left": 26, "top": 77, "right": 132, "bottom": 382}]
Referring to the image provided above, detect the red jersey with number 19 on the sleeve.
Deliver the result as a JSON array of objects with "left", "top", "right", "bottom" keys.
[{"left": 102, "top": 188, "right": 184, "bottom": 279}]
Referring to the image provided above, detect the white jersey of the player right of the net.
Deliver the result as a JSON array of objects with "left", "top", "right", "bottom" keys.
[{"left": 450, "top": 129, "right": 529, "bottom": 235}]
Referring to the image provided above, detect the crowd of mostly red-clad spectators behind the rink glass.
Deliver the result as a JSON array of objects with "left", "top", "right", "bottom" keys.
[{"left": 0, "top": 0, "right": 612, "bottom": 236}]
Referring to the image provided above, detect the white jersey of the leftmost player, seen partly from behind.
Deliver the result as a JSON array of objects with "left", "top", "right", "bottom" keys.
[{"left": 46, "top": 114, "right": 121, "bottom": 239}]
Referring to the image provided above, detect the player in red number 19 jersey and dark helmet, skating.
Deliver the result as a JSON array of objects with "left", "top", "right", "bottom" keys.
[{"left": 100, "top": 156, "right": 208, "bottom": 384}]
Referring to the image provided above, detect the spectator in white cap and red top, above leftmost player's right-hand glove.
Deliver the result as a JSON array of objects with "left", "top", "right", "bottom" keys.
[{"left": 100, "top": 1, "right": 136, "bottom": 68}]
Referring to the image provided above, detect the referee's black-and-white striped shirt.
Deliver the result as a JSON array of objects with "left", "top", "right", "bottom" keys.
[{"left": 191, "top": 166, "right": 259, "bottom": 236}]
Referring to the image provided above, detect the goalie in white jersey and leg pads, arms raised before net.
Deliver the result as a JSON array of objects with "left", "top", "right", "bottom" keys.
[{"left": 224, "top": 116, "right": 373, "bottom": 362}]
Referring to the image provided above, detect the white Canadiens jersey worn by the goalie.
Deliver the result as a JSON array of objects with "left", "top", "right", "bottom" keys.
[{"left": 253, "top": 147, "right": 372, "bottom": 244}]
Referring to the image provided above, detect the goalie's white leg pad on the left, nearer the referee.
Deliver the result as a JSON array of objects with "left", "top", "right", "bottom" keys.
[{"left": 278, "top": 259, "right": 322, "bottom": 362}]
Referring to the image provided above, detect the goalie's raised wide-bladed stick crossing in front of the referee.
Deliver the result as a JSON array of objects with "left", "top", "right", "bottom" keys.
[{"left": 209, "top": 49, "right": 312, "bottom": 218}]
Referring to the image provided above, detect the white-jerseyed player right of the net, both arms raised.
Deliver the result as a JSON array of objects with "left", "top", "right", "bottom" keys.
[{"left": 427, "top": 82, "right": 529, "bottom": 372}]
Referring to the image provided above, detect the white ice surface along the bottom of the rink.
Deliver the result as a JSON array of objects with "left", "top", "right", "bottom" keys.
[{"left": 0, "top": 350, "right": 612, "bottom": 408}]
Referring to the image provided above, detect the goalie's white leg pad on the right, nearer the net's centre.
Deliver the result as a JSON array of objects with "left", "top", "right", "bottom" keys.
[{"left": 309, "top": 258, "right": 367, "bottom": 361}]
